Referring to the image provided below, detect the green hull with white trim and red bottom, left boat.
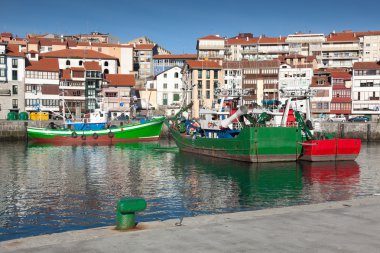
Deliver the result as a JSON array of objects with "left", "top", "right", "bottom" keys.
[{"left": 27, "top": 117, "right": 165, "bottom": 145}]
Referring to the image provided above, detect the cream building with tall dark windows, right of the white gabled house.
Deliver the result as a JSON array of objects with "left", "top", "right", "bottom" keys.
[{"left": 182, "top": 60, "right": 223, "bottom": 118}]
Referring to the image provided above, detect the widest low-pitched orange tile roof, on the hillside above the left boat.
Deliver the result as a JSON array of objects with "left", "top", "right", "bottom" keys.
[{"left": 40, "top": 49, "right": 117, "bottom": 60}]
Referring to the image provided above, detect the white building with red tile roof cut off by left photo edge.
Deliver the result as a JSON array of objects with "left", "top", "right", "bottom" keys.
[{"left": 0, "top": 44, "right": 25, "bottom": 119}]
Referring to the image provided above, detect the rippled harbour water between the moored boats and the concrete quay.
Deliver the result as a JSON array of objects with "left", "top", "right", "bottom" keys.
[{"left": 0, "top": 140, "right": 380, "bottom": 241}]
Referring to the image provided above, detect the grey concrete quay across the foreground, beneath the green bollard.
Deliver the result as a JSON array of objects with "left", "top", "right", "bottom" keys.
[{"left": 0, "top": 196, "right": 380, "bottom": 253}]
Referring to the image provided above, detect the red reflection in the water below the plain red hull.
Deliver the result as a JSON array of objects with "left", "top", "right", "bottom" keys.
[{"left": 300, "top": 161, "right": 360, "bottom": 202}]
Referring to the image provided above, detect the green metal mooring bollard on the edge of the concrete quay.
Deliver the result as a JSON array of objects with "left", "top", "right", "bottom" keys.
[{"left": 116, "top": 197, "right": 146, "bottom": 230}]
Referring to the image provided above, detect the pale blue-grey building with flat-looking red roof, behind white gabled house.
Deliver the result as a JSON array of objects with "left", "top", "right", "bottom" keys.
[{"left": 153, "top": 54, "right": 197, "bottom": 76}]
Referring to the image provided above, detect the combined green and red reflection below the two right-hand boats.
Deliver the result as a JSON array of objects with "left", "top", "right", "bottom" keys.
[{"left": 171, "top": 153, "right": 360, "bottom": 212}]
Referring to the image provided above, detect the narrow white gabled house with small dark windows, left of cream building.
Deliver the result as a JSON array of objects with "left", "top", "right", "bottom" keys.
[{"left": 154, "top": 66, "right": 182, "bottom": 107}]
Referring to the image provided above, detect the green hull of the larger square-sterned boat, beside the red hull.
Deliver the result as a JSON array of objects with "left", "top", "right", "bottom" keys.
[{"left": 169, "top": 124, "right": 302, "bottom": 162}]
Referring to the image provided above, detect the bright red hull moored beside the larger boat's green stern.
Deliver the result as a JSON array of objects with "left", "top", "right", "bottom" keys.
[{"left": 300, "top": 139, "right": 361, "bottom": 161}]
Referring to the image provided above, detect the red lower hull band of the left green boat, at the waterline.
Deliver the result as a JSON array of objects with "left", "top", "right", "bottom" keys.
[{"left": 32, "top": 135, "right": 159, "bottom": 146}]
